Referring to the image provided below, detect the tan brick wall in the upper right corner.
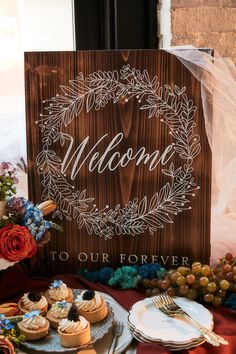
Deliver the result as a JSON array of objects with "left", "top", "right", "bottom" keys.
[{"left": 171, "top": 0, "right": 236, "bottom": 63}]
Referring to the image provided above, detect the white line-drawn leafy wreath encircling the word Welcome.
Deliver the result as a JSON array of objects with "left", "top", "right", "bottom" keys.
[{"left": 36, "top": 65, "right": 201, "bottom": 239}]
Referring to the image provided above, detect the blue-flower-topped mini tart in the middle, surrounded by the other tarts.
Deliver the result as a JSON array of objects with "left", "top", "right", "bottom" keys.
[{"left": 46, "top": 300, "right": 71, "bottom": 329}]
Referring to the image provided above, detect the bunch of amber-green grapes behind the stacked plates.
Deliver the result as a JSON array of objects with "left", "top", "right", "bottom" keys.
[{"left": 143, "top": 253, "right": 236, "bottom": 306}]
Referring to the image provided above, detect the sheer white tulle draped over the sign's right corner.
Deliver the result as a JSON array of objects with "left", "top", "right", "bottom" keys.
[{"left": 167, "top": 46, "right": 236, "bottom": 262}]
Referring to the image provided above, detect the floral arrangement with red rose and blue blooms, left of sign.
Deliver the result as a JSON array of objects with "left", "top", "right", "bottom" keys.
[{"left": 0, "top": 162, "right": 61, "bottom": 270}]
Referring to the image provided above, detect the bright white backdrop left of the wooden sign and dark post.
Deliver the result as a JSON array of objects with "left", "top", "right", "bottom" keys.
[{"left": 0, "top": 0, "right": 74, "bottom": 196}]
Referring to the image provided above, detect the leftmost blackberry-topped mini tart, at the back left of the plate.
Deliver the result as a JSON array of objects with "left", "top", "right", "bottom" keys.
[{"left": 18, "top": 291, "right": 48, "bottom": 315}]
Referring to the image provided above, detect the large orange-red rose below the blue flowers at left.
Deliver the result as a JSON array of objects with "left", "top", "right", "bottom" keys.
[{"left": 0, "top": 224, "right": 37, "bottom": 262}]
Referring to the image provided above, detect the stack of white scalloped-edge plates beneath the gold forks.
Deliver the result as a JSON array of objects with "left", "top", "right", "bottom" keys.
[{"left": 128, "top": 297, "right": 213, "bottom": 351}]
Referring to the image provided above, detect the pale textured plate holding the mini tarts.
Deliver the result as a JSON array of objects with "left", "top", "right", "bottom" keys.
[{"left": 22, "top": 302, "right": 114, "bottom": 354}]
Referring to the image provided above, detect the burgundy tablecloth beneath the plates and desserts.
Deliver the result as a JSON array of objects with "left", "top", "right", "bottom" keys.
[{"left": 0, "top": 264, "right": 236, "bottom": 354}]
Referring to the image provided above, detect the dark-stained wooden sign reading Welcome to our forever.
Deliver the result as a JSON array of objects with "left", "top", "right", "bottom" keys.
[{"left": 25, "top": 50, "right": 211, "bottom": 274}]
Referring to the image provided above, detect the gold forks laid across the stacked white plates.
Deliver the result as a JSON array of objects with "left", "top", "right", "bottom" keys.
[{"left": 152, "top": 293, "right": 229, "bottom": 346}]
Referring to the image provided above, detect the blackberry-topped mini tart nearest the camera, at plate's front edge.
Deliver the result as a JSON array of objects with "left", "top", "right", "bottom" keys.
[{"left": 58, "top": 306, "right": 91, "bottom": 348}]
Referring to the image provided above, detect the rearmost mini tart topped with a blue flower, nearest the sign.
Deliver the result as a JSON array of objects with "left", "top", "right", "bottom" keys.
[{"left": 44, "top": 280, "right": 73, "bottom": 305}]
